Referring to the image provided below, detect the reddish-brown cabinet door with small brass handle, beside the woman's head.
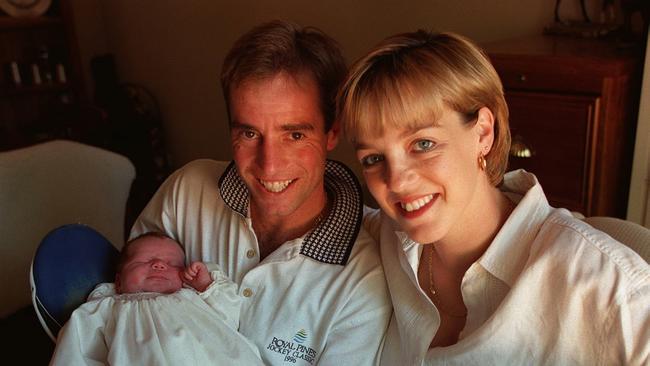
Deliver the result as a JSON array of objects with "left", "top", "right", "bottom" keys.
[{"left": 506, "top": 92, "right": 599, "bottom": 214}]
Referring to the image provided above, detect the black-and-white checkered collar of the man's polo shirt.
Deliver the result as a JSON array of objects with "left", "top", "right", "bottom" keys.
[{"left": 219, "top": 160, "right": 363, "bottom": 265}]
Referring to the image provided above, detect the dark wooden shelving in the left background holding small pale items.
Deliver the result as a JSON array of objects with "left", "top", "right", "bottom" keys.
[{"left": 0, "top": 0, "right": 83, "bottom": 150}]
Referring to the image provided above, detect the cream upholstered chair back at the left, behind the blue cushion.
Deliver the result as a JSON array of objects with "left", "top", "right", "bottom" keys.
[{"left": 0, "top": 140, "right": 135, "bottom": 317}]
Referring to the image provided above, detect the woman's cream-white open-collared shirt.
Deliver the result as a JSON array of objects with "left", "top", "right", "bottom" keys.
[{"left": 365, "top": 170, "right": 650, "bottom": 366}]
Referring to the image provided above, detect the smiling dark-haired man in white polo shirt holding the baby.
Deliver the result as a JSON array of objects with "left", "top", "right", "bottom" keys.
[{"left": 131, "top": 21, "right": 392, "bottom": 365}]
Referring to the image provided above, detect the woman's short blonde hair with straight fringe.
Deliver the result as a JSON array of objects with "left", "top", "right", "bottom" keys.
[{"left": 337, "top": 30, "right": 510, "bottom": 186}]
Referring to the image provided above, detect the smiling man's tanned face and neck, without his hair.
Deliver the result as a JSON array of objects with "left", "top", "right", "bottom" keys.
[{"left": 230, "top": 73, "right": 338, "bottom": 221}]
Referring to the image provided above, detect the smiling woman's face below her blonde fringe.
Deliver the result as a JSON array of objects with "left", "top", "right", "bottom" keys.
[{"left": 356, "top": 108, "right": 491, "bottom": 243}]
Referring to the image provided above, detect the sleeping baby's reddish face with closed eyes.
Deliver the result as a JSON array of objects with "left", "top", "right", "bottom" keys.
[{"left": 115, "top": 236, "right": 185, "bottom": 294}]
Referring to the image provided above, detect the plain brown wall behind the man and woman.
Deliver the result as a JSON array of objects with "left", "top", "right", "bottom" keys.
[{"left": 66, "top": 0, "right": 604, "bottom": 177}]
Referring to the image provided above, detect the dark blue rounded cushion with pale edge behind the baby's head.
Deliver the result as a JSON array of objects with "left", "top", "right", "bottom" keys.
[{"left": 32, "top": 224, "right": 119, "bottom": 337}]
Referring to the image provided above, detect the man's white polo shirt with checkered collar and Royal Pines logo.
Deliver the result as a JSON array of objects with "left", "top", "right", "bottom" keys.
[{"left": 131, "top": 160, "right": 392, "bottom": 366}]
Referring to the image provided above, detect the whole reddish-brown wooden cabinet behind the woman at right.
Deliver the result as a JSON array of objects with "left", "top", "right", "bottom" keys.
[{"left": 484, "top": 36, "right": 642, "bottom": 218}]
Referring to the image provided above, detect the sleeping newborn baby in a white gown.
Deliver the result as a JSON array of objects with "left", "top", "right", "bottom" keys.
[{"left": 50, "top": 233, "right": 262, "bottom": 365}]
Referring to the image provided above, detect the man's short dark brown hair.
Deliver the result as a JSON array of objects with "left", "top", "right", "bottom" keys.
[{"left": 221, "top": 20, "right": 346, "bottom": 132}]
